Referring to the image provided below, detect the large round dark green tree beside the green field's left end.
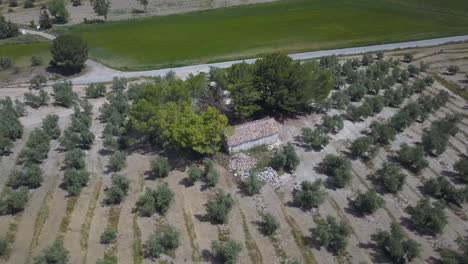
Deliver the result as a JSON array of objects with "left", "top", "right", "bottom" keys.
[{"left": 50, "top": 34, "right": 88, "bottom": 72}]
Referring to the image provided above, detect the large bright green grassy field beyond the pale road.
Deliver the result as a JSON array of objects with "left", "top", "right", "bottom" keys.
[{"left": 0, "top": 0, "right": 468, "bottom": 70}]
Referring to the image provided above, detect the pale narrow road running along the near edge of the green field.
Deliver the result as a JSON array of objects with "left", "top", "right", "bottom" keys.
[{"left": 24, "top": 29, "right": 468, "bottom": 84}]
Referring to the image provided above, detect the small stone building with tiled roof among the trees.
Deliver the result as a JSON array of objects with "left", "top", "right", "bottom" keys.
[{"left": 224, "top": 118, "right": 281, "bottom": 153}]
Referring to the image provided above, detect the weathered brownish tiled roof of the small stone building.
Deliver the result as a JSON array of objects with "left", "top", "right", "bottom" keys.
[{"left": 226, "top": 118, "right": 281, "bottom": 147}]
